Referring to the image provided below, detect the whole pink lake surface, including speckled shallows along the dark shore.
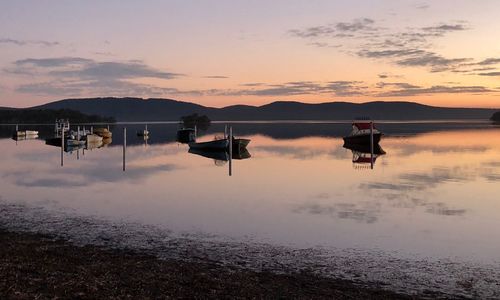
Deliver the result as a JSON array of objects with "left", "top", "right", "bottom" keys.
[{"left": 0, "top": 122, "right": 500, "bottom": 297}]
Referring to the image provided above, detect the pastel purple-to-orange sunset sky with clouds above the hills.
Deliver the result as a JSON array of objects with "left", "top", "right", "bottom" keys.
[{"left": 0, "top": 0, "right": 500, "bottom": 108}]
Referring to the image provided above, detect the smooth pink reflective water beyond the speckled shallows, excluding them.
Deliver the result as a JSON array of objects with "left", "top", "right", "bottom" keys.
[{"left": 0, "top": 123, "right": 500, "bottom": 296}]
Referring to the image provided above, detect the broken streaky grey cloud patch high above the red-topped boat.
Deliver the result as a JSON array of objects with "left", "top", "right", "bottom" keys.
[{"left": 289, "top": 18, "right": 472, "bottom": 72}]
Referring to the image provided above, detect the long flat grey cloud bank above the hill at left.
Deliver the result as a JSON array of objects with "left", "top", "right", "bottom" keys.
[{"left": 8, "top": 57, "right": 189, "bottom": 96}]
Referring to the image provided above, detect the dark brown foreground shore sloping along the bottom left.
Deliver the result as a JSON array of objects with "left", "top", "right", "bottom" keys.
[{"left": 0, "top": 228, "right": 436, "bottom": 299}]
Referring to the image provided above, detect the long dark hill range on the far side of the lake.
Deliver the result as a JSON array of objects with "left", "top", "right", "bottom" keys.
[{"left": 26, "top": 98, "right": 497, "bottom": 121}]
